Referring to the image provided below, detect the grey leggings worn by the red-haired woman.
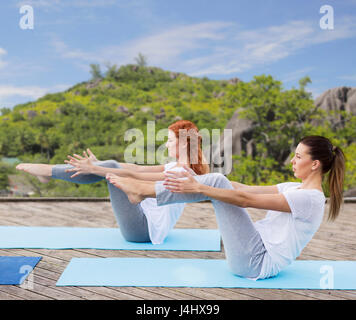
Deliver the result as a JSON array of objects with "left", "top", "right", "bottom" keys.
[{"left": 52, "top": 160, "right": 151, "bottom": 242}]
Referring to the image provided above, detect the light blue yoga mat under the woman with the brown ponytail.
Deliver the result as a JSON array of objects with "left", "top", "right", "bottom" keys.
[{"left": 57, "top": 258, "right": 356, "bottom": 290}]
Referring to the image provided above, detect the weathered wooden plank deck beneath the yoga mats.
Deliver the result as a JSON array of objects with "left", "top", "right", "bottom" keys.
[{"left": 0, "top": 199, "right": 356, "bottom": 300}]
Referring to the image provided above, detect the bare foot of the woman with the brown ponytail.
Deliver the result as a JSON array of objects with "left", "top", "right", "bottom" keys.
[{"left": 106, "top": 173, "right": 145, "bottom": 204}]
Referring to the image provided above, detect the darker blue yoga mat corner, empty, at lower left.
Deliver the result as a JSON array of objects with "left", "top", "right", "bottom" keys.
[{"left": 0, "top": 256, "right": 41, "bottom": 285}]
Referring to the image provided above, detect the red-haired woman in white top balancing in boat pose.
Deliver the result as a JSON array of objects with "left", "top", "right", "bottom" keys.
[{"left": 16, "top": 120, "right": 209, "bottom": 244}]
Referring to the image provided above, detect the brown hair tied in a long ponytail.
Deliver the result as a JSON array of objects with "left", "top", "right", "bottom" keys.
[{"left": 300, "top": 136, "right": 345, "bottom": 221}]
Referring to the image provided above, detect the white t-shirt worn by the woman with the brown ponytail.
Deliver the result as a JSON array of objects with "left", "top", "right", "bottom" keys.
[{"left": 255, "top": 182, "right": 325, "bottom": 279}]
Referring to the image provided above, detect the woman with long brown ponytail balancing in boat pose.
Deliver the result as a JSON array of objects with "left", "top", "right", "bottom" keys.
[{"left": 110, "top": 136, "right": 345, "bottom": 280}]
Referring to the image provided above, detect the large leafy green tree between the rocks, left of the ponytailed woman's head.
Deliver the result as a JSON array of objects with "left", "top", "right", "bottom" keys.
[{"left": 229, "top": 75, "right": 322, "bottom": 184}]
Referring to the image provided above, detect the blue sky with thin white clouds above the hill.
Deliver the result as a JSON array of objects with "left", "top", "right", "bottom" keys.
[{"left": 0, "top": 0, "right": 356, "bottom": 108}]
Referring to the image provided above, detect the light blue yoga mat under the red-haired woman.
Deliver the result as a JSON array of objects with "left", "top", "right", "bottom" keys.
[{"left": 0, "top": 226, "right": 221, "bottom": 251}]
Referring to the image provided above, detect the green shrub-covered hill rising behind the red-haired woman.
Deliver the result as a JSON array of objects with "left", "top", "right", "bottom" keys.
[{"left": 0, "top": 65, "right": 234, "bottom": 163}]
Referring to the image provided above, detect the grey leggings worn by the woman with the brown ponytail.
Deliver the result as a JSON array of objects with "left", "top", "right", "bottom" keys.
[{"left": 155, "top": 173, "right": 266, "bottom": 278}]
